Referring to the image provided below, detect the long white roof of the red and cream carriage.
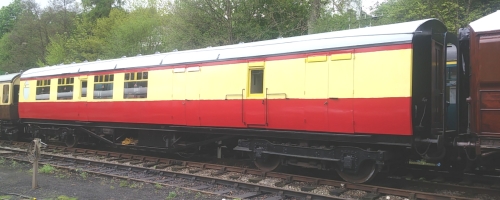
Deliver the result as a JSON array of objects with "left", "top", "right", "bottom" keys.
[{"left": 21, "top": 19, "right": 437, "bottom": 78}]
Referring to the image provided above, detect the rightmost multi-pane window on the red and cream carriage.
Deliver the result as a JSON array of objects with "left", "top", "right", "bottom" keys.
[{"left": 123, "top": 72, "right": 148, "bottom": 99}]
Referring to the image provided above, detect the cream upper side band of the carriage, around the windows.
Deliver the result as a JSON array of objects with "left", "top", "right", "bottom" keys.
[{"left": 20, "top": 49, "right": 412, "bottom": 102}]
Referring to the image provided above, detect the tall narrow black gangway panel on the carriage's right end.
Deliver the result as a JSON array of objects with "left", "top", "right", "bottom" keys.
[{"left": 431, "top": 40, "right": 446, "bottom": 133}]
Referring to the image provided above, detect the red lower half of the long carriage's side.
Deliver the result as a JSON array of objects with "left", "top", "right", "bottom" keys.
[{"left": 19, "top": 97, "right": 412, "bottom": 135}]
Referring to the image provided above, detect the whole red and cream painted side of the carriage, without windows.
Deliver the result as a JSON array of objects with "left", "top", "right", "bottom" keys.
[{"left": 19, "top": 44, "right": 412, "bottom": 135}]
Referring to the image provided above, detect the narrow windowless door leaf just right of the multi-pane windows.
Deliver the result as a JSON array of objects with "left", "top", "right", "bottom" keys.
[{"left": 170, "top": 68, "right": 186, "bottom": 125}]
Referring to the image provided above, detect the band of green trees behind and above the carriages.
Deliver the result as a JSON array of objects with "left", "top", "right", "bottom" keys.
[{"left": 0, "top": 0, "right": 500, "bottom": 74}]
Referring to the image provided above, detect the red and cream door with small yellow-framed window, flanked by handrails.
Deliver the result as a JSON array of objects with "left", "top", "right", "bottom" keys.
[{"left": 243, "top": 62, "right": 267, "bottom": 126}]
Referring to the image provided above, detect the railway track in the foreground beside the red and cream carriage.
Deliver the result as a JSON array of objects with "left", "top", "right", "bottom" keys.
[{"left": 0, "top": 141, "right": 500, "bottom": 200}]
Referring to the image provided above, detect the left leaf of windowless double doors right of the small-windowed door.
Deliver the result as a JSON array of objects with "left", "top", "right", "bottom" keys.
[{"left": 303, "top": 54, "right": 328, "bottom": 131}]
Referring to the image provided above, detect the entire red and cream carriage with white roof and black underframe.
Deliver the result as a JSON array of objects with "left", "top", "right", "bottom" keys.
[{"left": 0, "top": 11, "right": 498, "bottom": 183}]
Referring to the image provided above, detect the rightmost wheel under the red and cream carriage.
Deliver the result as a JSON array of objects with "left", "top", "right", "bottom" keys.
[{"left": 337, "top": 161, "right": 377, "bottom": 183}]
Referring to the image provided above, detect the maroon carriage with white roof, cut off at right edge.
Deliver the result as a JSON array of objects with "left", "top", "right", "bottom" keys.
[{"left": 458, "top": 10, "right": 500, "bottom": 170}]
